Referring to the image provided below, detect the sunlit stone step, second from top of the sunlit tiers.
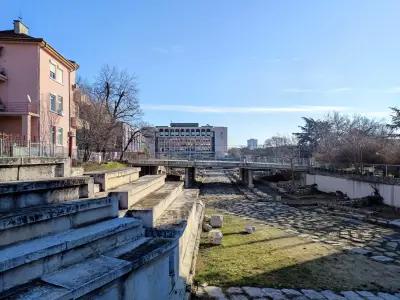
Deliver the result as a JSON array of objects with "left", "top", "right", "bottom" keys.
[{"left": 109, "top": 175, "right": 165, "bottom": 209}]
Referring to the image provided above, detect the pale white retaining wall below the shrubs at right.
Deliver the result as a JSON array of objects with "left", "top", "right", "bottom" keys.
[{"left": 306, "top": 174, "right": 400, "bottom": 207}]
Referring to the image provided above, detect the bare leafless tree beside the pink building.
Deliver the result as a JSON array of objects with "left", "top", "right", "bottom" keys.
[{"left": 77, "top": 66, "right": 142, "bottom": 159}]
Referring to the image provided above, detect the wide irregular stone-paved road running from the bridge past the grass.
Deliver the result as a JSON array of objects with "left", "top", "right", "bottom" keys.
[{"left": 201, "top": 172, "right": 400, "bottom": 266}]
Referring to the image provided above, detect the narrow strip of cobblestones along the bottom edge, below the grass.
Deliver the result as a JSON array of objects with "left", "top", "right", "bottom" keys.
[{"left": 196, "top": 286, "right": 400, "bottom": 300}]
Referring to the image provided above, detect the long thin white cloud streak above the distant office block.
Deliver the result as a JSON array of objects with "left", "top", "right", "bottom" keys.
[{"left": 142, "top": 104, "right": 350, "bottom": 114}]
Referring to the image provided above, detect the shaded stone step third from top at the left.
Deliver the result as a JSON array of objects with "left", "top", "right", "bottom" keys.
[{"left": 0, "top": 197, "right": 118, "bottom": 248}]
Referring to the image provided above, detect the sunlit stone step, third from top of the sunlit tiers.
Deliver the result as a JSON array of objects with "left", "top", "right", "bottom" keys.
[{"left": 127, "top": 181, "right": 183, "bottom": 227}]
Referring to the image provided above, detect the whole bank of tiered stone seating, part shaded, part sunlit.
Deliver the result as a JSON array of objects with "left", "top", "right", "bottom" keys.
[{"left": 0, "top": 165, "right": 203, "bottom": 299}]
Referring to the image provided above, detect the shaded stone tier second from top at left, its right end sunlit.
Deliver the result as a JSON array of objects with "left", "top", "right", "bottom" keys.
[{"left": 0, "top": 177, "right": 93, "bottom": 213}]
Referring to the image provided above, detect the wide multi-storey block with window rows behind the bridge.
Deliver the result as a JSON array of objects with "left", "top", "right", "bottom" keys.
[{"left": 155, "top": 123, "right": 228, "bottom": 159}]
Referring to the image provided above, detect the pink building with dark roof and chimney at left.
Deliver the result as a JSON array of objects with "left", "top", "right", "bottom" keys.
[{"left": 0, "top": 20, "right": 79, "bottom": 155}]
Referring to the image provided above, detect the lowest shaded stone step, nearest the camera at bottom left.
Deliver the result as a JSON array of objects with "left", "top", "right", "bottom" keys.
[{"left": 0, "top": 238, "right": 179, "bottom": 300}]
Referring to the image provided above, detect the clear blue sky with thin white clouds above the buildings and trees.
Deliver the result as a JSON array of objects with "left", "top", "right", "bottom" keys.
[{"left": 0, "top": 0, "right": 400, "bottom": 145}]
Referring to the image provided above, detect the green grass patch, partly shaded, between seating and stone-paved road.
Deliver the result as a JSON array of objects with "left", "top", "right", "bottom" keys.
[{"left": 195, "top": 210, "right": 400, "bottom": 290}]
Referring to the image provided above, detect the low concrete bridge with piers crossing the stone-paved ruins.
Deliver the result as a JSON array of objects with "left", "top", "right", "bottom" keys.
[{"left": 129, "top": 159, "right": 309, "bottom": 187}]
